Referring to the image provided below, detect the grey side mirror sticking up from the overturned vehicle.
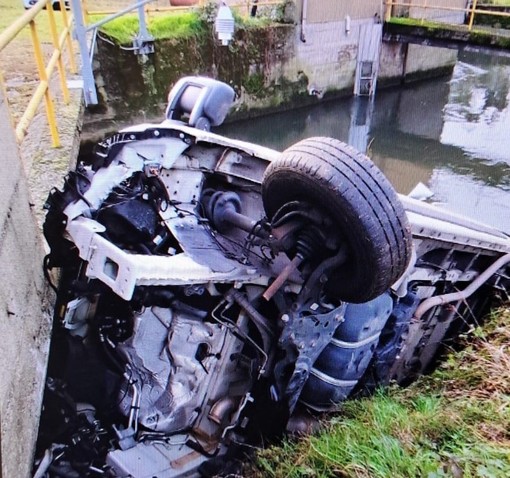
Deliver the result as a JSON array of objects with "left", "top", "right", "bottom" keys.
[{"left": 166, "top": 76, "right": 235, "bottom": 131}]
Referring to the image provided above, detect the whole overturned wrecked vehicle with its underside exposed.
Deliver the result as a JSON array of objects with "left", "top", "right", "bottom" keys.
[{"left": 35, "top": 78, "right": 510, "bottom": 478}]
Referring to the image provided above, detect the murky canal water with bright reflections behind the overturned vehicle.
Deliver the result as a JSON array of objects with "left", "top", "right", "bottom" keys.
[{"left": 218, "top": 53, "right": 510, "bottom": 233}]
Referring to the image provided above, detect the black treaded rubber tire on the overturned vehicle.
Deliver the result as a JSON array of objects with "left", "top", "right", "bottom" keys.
[{"left": 262, "top": 137, "right": 412, "bottom": 303}]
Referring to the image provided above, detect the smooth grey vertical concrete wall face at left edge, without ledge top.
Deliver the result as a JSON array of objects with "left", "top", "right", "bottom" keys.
[{"left": 0, "top": 89, "right": 51, "bottom": 478}]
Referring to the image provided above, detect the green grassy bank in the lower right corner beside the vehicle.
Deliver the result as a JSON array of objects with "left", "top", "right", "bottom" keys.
[{"left": 246, "top": 310, "right": 510, "bottom": 478}]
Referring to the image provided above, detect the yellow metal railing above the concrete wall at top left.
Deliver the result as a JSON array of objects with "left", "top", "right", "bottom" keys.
[{"left": 0, "top": 0, "right": 76, "bottom": 147}]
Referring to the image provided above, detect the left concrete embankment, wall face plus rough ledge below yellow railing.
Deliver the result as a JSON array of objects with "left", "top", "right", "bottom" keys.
[{"left": 0, "top": 81, "right": 83, "bottom": 478}]
